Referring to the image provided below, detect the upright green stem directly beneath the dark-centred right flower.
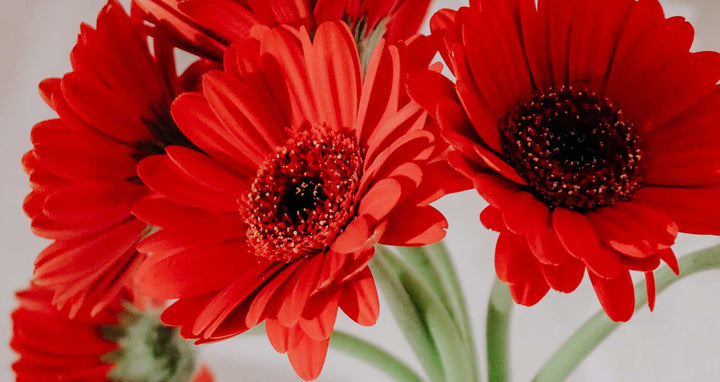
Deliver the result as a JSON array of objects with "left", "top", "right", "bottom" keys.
[{"left": 486, "top": 278, "right": 513, "bottom": 382}]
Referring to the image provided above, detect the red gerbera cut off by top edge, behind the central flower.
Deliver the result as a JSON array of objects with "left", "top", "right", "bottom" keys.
[{"left": 133, "top": 0, "right": 430, "bottom": 61}]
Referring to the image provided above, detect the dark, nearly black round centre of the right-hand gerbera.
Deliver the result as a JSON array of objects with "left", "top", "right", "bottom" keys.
[{"left": 501, "top": 87, "right": 645, "bottom": 211}]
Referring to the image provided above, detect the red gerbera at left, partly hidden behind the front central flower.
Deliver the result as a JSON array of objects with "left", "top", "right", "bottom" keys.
[{"left": 23, "top": 0, "right": 215, "bottom": 314}]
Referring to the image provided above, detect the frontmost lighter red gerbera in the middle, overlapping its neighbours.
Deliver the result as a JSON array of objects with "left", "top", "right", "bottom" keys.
[{"left": 134, "top": 23, "right": 462, "bottom": 379}]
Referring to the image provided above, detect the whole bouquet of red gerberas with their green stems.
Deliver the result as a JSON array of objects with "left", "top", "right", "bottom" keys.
[{"left": 11, "top": 0, "right": 720, "bottom": 382}]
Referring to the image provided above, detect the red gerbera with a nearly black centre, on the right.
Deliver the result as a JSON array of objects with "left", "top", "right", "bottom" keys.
[{"left": 411, "top": 0, "right": 720, "bottom": 321}]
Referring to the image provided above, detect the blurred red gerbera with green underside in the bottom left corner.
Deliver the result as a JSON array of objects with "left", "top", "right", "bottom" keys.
[{"left": 10, "top": 285, "right": 212, "bottom": 382}]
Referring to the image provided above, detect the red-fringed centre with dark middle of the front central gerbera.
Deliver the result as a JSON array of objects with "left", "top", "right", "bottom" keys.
[{"left": 244, "top": 129, "right": 362, "bottom": 262}]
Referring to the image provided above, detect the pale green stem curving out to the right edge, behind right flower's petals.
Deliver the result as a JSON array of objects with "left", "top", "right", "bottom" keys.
[{"left": 533, "top": 245, "right": 720, "bottom": 382}]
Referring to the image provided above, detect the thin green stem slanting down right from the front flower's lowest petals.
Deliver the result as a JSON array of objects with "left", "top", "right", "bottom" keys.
[{"left": 330, "top": 330, "right": 423, "bottom": 382}]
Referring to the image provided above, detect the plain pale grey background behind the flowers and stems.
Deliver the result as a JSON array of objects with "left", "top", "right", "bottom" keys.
[{"left": 0, "top": 0, "right": 720, "bottom": 382}]
